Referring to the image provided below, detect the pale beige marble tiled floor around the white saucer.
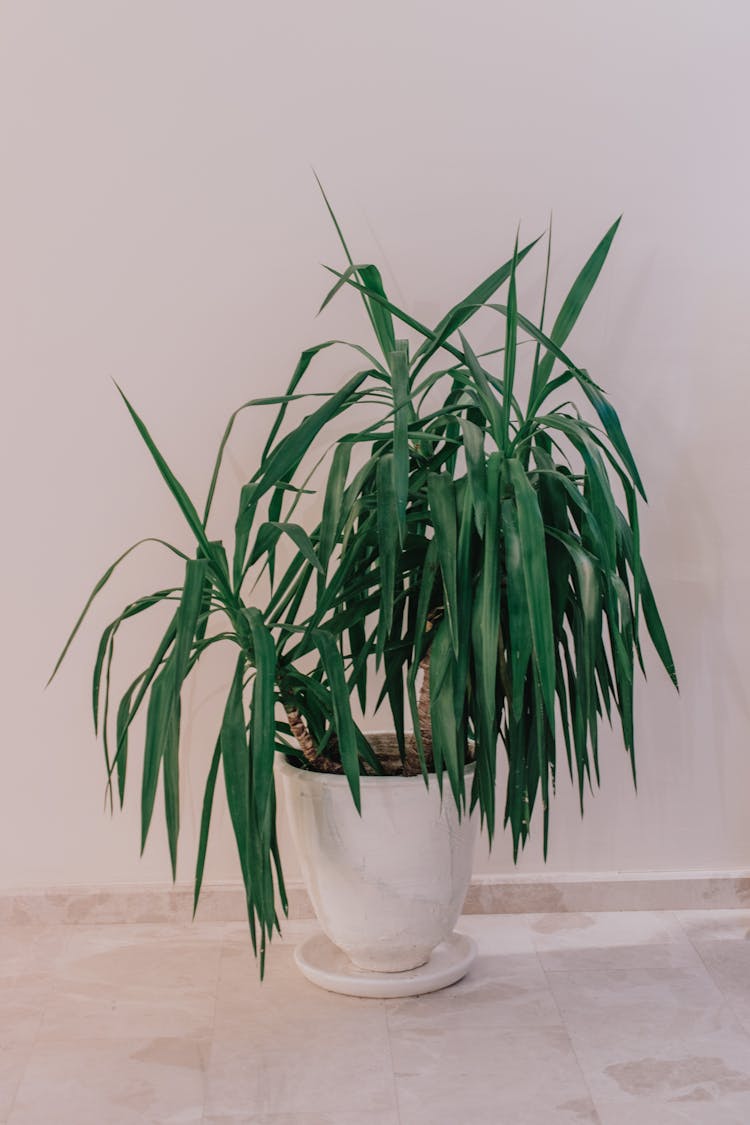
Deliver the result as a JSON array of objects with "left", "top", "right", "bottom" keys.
[{"left": 0, "top": 910, "right": 750, "bottom": 1125}]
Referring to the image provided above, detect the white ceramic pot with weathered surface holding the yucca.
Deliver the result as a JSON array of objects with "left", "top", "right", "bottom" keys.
[{"left": 277, "top": 742, "right": 478, "bottom": 973}]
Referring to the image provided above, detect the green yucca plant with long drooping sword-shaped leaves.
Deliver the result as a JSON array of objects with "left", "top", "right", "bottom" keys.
[{"left": 53, "top": 196, "right": 677, "bottom": 964}]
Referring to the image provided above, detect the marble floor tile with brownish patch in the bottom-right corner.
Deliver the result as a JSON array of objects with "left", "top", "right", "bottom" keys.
[{"left": 548, "top": 966, "right": 750, "bottom": 1125}]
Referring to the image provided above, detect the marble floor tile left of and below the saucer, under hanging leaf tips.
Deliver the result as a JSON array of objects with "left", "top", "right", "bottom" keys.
[{"left": 205, "top": 923, "right": 396, "bottom": 1125}]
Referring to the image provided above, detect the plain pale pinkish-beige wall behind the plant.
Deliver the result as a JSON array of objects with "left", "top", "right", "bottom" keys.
[{"left": 0, "top": 0, "right": 750, "bottom": 889}]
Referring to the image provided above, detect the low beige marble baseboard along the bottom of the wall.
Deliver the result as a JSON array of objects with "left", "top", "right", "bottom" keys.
[{"left": 0, "top": 872, "right": 750, "bottom": 926}]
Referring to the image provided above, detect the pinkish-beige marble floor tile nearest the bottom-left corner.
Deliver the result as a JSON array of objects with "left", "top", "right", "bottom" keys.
[{"left": 8, "top": 1038, "right": 208, "bottom": 1125}]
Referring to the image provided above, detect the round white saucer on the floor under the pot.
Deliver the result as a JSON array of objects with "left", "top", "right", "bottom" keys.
[{"left": 295, "top": 933, "right": 477, "bottom": 1000}]
